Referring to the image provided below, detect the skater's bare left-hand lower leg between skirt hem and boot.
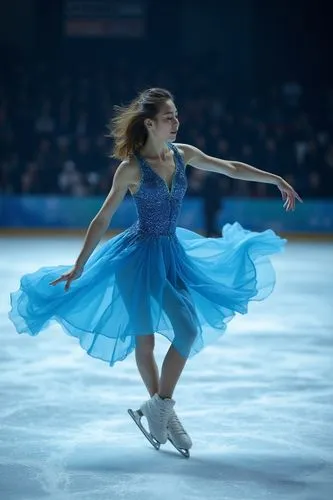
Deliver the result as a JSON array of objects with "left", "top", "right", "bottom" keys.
[{"left": 135, "top": 334, "right": 159, "bottom": 396}]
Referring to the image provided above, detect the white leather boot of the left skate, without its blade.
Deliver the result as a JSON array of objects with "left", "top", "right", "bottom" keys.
[{"left": 140, "top": 393, "right": 175, "bottom": 444}]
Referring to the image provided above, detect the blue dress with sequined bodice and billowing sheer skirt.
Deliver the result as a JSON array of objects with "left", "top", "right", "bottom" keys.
[{"left": 9, "top": 143, "right": 286, "bottom": 366}]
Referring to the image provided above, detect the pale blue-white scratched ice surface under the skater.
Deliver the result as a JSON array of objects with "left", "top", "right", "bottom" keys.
[{"left": 0, "top": 237, "right": 333, "bottom": 500}]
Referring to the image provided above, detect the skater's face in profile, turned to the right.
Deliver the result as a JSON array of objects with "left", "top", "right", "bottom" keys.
[{"left": 148, "top": 99, "right": 179, "bottom": 141}]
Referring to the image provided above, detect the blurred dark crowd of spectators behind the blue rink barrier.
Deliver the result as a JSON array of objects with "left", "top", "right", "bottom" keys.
[{"left": 0, "top": 60, "right": 333, "bottom": 200}]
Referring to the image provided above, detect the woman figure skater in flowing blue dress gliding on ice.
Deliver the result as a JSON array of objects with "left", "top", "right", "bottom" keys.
[{"left": 9, "top": 88, "right": 302, "bottom": 458}]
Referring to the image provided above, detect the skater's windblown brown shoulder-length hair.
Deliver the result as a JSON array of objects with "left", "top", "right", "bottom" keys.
[{"left": 109, "top": 88, "right": 173, "bottom": 160}]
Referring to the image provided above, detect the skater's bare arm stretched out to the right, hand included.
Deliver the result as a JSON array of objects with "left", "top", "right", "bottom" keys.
[{"left": 176, "top": 144, "right": 303, "bottom": 211}]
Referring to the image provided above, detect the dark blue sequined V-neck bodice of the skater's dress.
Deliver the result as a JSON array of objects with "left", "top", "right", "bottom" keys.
[{"left": 132, "top": 143, "right": 187, "bottom": 236}]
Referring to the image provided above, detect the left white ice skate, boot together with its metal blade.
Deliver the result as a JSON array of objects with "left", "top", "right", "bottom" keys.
[{"left": 128, "top": 394, "right": 175, "bottom": 450}]
